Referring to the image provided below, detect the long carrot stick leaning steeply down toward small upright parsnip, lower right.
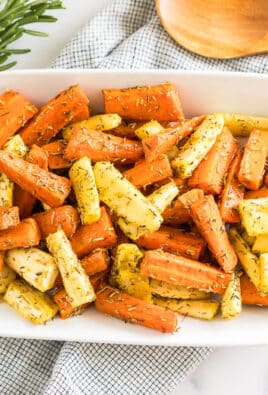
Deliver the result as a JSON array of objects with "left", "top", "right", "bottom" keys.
[{"left": 190, "top": 195, "right": 237, "bottom": 272}]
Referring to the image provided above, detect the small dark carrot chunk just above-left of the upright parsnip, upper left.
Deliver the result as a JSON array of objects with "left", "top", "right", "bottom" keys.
[{"left": 42, "top": 140, "right": 72, "bottom": 169}]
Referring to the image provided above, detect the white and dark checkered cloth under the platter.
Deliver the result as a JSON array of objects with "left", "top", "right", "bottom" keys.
[{"left": 0, "top": 0, "right": 268, "bottom": 395}]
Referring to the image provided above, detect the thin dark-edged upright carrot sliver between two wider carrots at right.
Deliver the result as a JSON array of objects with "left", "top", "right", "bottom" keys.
[{"left": 219, "top": 151, "right": 245, "bottom": 223}]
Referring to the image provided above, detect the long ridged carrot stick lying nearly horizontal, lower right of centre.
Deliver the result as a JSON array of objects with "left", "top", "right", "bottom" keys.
[{"left": 140, "top": 250, "right": 231, "bottom": 294}]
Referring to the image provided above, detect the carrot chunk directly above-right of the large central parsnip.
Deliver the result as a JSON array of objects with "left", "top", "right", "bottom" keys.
[{"left": 123, "top": 155, "right": 172, "bottom": 188}]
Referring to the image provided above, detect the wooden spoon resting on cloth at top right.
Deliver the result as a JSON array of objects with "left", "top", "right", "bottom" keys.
[{"left": 155, "top": 0, "right": 268, "bottom": 59}]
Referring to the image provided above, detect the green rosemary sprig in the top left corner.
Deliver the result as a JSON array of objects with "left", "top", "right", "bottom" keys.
[{"left": 0, "top": 0, "right": 64, "bottom": 71}]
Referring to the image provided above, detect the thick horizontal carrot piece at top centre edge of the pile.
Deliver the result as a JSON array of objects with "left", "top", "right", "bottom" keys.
[{"left": 103, "top": 83, "right": 184, "bottom": 121}]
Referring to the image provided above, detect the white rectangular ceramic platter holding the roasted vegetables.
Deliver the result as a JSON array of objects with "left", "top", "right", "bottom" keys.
[{"left": 0, "top": 70, "right": 268, "bottom": 346}]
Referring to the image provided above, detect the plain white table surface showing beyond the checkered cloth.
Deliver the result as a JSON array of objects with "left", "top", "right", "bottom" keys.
[{"left": 7, "top": 0, "right": 268, "bottom": 395}]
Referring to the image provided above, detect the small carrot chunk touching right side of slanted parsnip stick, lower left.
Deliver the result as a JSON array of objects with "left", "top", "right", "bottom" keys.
[{"left": 80, "top": 248, "right": 109, "bottom": 276}]
